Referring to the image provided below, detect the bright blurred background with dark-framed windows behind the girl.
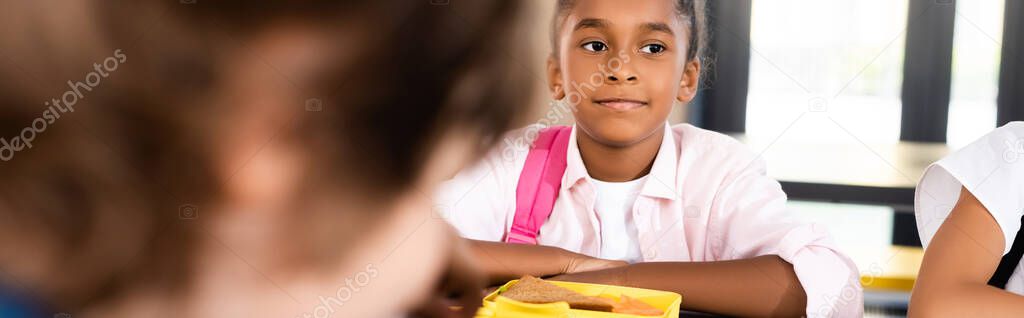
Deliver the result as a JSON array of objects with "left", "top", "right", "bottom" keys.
[{"left": 523, "top": 0, "right": 1024, "bottom": 317}]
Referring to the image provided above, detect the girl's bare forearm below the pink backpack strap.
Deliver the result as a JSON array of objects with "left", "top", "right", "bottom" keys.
[{"left": 469, "top": 240, "right": 626, "bottom": 284}]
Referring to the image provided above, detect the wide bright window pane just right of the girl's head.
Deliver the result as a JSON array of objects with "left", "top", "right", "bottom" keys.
[{"left": 749, "top": 0, "right": 908, "bottom": 143}]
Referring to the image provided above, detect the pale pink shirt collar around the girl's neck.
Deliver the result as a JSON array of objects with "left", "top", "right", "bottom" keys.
[{"left": 562, "top": 123, "right": 679, "bottom": 199}]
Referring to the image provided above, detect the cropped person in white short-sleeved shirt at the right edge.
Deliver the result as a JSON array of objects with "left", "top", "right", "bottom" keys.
[{"left": 908, "top": 122, "right": 1024, "bottom": 317}]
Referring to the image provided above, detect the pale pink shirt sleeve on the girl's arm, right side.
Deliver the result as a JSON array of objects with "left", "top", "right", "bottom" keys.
[{"left": 698, "top": 151, "right": 863, "bottom": 317}]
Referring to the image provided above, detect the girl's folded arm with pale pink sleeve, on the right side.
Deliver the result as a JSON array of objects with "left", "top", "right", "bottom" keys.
[{"left": 557, "top": 155, "right": 863, "bottom": 317}]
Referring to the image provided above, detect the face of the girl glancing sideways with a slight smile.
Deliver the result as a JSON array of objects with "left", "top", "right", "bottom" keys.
[{"left": 548, "top": 0, "right": 700, "bottom": 147}]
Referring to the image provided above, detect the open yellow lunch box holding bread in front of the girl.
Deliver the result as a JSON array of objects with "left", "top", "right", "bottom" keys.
[{"left": 476, "top": 279, "right": 683, "bottom": 318}]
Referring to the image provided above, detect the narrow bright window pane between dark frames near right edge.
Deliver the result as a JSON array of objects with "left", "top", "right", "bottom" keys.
[{"left": 946, "top": 0, "right": 1006, "bottom": 148}]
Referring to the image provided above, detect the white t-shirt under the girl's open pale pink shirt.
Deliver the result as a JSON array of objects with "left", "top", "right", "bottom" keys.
[{"left": 590, "top": 176, "right": 647, "bottom": 264}]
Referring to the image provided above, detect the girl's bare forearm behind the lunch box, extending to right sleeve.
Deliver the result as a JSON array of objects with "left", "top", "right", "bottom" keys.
[{"left": 554, "top": 256, "right": 807, "bottom": 317}]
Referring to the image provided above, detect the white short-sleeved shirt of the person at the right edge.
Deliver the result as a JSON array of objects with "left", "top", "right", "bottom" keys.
[{"left": 914, "top": 122, "right": 1024, "bottom": 294}]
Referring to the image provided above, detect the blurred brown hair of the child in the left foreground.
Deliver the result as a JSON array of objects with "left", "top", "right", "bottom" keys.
[{"left": 0, "top": 0, "right": 531, "bottom": 314}]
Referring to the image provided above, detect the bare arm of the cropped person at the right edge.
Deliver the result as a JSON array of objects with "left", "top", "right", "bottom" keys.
[{"left": 908, "top": 188, "right": 1024, "bottom": 317}]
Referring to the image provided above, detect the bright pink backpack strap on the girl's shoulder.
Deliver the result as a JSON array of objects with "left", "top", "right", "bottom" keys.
[{"left": 505, "top": 126, "right": 572, "bottom": 244}]
